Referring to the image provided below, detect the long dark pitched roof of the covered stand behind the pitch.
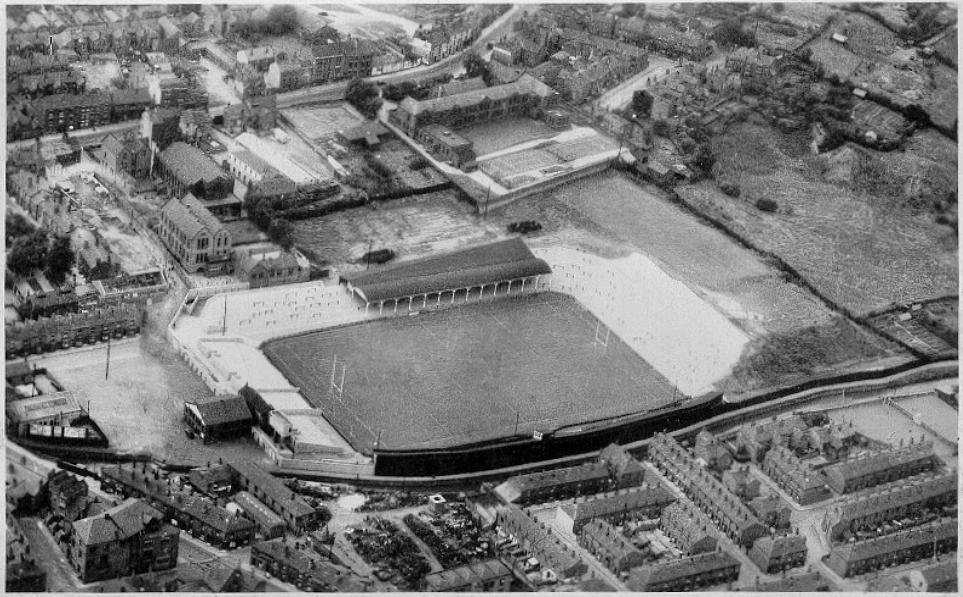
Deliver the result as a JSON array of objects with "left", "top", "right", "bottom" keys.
[{"left": 343, "top": 238, "right": 552, "bottom": 302}]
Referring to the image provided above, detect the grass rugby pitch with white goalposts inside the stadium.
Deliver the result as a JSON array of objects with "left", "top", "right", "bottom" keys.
[{"left": 263, "top": 294, "right": 676, "bottom": 452}]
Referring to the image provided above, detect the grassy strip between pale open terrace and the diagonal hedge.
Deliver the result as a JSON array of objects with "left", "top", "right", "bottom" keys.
[{"left": 490, "top": 173, "right": 906, "bottom": 396}]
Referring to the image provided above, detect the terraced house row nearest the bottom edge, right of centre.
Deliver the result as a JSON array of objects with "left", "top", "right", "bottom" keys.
[{"left": 626, "top": 551, "right": 742, "bottom": 593}]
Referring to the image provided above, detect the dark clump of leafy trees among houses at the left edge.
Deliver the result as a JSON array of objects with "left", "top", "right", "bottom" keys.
[{"left": 5, "top": 214, "right": 76, "bottom": 284}]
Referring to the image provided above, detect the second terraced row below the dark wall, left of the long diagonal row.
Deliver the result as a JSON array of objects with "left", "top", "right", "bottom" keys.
[{"left": 554, "top": 483, "right": 676, "bottom": 535}]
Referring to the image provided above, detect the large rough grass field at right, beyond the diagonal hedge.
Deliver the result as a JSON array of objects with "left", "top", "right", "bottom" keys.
[{"left": 679, "top": 123, "right": 958, "bottom": 315}]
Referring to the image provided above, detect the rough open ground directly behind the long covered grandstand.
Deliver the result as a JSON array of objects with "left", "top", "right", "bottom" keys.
[{"left": 293, "top": 191, "right": 505, "bottom": 271}]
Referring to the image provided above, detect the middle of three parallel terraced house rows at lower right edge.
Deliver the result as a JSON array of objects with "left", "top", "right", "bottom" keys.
[{"left": 822, "top": 472, "right": 957, "bottom": 541}]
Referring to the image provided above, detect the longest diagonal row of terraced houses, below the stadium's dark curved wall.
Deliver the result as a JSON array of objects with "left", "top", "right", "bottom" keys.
[{"left": 649, "top": 433, "right": 767, "bottom": 547}]
